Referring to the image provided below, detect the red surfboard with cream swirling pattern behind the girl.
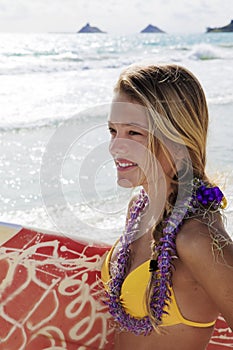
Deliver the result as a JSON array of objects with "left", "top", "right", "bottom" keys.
[{"left": 0, "top": 223, "right": 233, "bottom": 350}]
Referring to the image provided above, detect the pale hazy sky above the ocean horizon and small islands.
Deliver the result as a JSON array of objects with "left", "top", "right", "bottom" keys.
[{"left": 0, "top": 0, "right": 233, "bottom": 34}]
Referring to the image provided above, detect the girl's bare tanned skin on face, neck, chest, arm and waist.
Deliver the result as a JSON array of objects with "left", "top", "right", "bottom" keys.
[{"left": 109, "top": 93, "right": 233, "bottom": 350}]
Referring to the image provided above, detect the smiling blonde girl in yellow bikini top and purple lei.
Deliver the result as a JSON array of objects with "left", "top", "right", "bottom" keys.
[{"left": 102, "top": 65, "right": 233, "bottom": 350}]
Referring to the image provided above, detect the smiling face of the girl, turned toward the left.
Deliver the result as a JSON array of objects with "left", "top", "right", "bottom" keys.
[{"left": 109, "top": 93, "right": 148, "bottom": 187}]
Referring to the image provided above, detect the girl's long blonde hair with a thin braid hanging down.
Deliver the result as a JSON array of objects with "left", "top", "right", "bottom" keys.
[{"left": 114, "top": 64, "right": 211, "bottom": 328}]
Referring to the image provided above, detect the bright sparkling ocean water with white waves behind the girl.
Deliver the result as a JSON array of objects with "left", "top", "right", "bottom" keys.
[{"left": 0, "top": 33, "right": 233, "bottom": 243}]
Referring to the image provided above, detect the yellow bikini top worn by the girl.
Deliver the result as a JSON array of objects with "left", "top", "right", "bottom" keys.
[{"left": 101, "top": 246, "right": 216, "bottom": 328}]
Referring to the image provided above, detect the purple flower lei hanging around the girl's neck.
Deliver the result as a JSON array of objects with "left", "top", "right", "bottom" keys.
[{"left": 106, "top": 178, "right": 224, "bottom": 335}]
